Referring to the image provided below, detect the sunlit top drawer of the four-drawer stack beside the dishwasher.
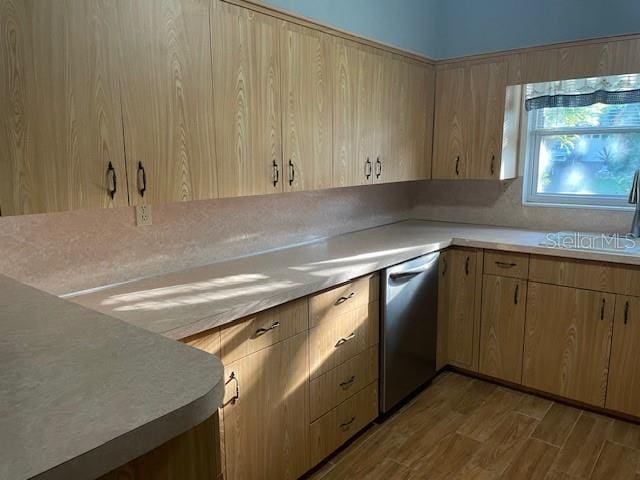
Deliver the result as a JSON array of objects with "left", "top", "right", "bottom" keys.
[{"left": 309, "top": 273, "right": 380, "bottom": 328}]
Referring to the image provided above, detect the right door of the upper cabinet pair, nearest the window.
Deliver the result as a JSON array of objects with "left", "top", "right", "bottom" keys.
[{"left": 467, "top": 62, "right": 508, "bottom": 179}]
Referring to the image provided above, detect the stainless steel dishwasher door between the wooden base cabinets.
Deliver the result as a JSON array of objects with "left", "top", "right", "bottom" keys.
[{"left": 380, "top": 252, "right": 440, "bottom": 413}]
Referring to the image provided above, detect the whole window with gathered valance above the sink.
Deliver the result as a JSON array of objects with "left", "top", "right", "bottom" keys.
[{"left": 524, "top": 75, "right": 640, "bottom": 208}]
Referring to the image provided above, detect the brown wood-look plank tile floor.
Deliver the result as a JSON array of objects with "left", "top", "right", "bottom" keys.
[{"left": 308, "top": 372, "right": 640, "bottom": 480}]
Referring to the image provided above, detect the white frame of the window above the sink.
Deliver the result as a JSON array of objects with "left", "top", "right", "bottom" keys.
[{"left": 521, "top": 104, "right": 640, "bottom": 211}]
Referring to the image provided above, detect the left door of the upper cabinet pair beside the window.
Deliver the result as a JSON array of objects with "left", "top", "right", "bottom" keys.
[{"left": 432, "top": 68, "right": 471, "bottom": 179}]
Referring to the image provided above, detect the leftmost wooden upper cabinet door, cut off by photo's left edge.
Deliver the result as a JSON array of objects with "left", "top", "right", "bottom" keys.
[{"left": 0, "top": 0, "right": 127, "bottom": 215}]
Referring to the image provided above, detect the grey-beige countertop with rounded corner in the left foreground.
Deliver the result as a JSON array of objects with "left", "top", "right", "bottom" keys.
[{"left": 0, "top": 275, "right": 224, "bottom": 480}]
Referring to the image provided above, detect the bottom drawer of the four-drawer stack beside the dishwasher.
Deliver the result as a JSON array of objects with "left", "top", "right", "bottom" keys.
[{"left": 309, "top": 382, "right": 378, "bottom": 466}]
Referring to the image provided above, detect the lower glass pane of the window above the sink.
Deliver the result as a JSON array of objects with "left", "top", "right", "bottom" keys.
[{"left": 536, "top": 133, "right": 640, "bottom": 197}]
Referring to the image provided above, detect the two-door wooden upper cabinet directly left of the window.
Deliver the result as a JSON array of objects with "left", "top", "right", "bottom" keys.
[{"left": 433, "top": 61, "right": 514, "bottom": 179}]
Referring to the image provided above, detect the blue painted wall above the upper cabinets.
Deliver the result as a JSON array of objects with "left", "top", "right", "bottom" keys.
[{"left": 264, "top": 0, "right": 640, "bottom": 58}]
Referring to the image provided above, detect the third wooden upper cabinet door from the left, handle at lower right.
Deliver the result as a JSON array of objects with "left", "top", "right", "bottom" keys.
[{"left": 211, "top": 2, "right": 284, "bottom": 197}]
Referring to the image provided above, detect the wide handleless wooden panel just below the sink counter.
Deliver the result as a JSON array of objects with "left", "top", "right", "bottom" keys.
[{"left": 529, "top": 255, "right": 640, "bottom": 296}]
